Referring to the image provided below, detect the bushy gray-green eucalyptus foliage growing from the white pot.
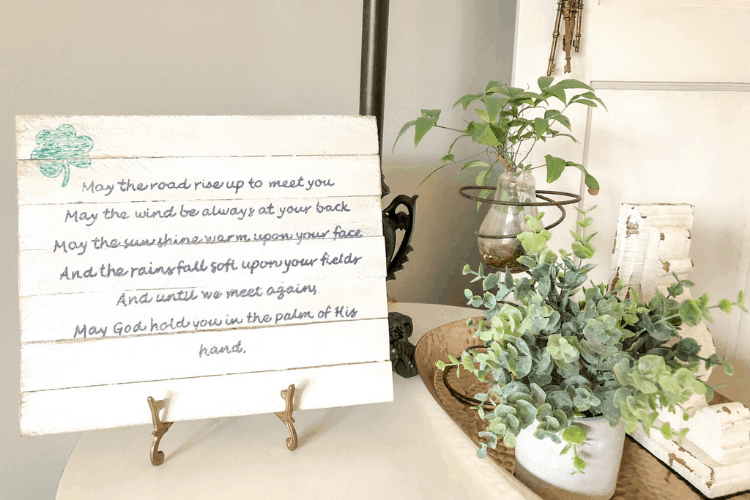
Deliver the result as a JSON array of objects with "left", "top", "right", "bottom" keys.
[{"left": 437, "top": 210, "right": 746, "bottom": 472}]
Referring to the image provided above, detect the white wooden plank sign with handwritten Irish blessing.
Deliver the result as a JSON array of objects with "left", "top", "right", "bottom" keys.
[{"left": 16, "top": 116, "right": 393, "bottom": 435}]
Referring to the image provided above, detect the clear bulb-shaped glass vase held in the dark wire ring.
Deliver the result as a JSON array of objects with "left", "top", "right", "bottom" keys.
[{"left": 477, "top": 170, "right": 537, "bottom": 268}]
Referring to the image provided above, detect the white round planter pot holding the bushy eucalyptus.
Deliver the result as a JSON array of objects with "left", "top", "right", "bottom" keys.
[{"left": 516, "top": 417, "right": 625, "bottom": 500}]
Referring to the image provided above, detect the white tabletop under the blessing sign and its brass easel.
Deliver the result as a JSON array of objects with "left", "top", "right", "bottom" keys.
[{"left": 57, "top": 304, "right": 538, "bottom": 500}]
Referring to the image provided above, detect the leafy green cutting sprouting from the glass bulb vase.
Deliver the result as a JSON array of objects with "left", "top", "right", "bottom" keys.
[{"left": 393, "top": 76, "right": 604, "bottom": 198}]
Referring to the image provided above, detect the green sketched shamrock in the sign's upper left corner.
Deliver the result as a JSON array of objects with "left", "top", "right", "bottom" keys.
[{"left": 31, "top": 124, "right": 94, "bottom": 187}]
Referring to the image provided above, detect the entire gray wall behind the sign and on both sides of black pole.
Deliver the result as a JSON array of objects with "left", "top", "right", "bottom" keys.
[{"left": 0, "top": 0, "right": 515, "bottom": 499}]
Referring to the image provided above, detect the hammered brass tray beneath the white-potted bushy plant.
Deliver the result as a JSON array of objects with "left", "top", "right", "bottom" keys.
[{"left": 415, "top": 320, "right": 750, "bottom": 500}]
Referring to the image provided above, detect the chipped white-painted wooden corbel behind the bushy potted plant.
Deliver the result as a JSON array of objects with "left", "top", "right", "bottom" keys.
[{"left": 609, "top": 204, "right": 750, "bottom": 498}]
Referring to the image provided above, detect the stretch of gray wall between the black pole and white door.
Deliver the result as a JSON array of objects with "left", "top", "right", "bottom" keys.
[{"left": 383, "top": 0, "right": 516, "bottom": 306}]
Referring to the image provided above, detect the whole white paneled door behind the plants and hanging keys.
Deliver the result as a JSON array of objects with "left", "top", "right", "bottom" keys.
[{"left": 514, "top": 0, "right": 750, "bottom": 405}]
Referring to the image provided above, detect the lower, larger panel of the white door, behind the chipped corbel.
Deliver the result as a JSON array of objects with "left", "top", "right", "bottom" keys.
[{"left": 585, "top": 90, "right": 750, "bottom": 356}]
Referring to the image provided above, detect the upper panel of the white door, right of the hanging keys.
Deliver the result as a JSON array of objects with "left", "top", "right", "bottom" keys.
[{"left": 584, "top": 3, "right": 750, "bottom": 82}]
